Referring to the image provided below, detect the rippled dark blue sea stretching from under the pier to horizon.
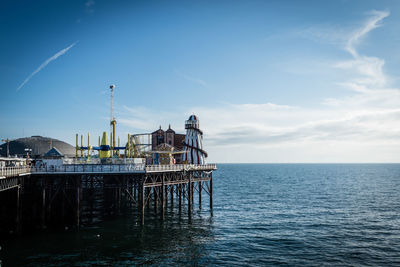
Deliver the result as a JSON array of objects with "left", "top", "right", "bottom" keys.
[{"left": 0, "top": 164, "right": 400, "bottom": 266}]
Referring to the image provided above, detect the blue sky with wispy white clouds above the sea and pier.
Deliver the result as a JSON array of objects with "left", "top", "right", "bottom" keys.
[{"left": 0, "top": 0, "right": 400, "bottom": 162}]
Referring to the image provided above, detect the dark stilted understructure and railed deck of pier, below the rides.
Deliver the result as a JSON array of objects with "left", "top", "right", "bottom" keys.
[{"left": 0, "top": 164, "right": 217, "bottom": 236}]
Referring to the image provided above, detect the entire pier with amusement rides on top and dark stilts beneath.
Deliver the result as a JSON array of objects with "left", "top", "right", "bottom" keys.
[{"left": 0, "top": 88, "right": 217, "bottom": 237}]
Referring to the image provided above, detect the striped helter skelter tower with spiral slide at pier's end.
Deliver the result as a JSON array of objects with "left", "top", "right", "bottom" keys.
[{"left": 182, "top": 115, "right": 207, "bottom": 164}]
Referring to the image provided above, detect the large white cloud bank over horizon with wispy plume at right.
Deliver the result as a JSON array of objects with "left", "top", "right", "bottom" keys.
[{"left": 120, "top": 11, "right": 400, "bottom": 162}]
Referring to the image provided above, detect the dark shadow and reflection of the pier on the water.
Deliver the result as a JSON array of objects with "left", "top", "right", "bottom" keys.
[{"left": 0, "top": 200, "right": 214, "bottom": 266}]
